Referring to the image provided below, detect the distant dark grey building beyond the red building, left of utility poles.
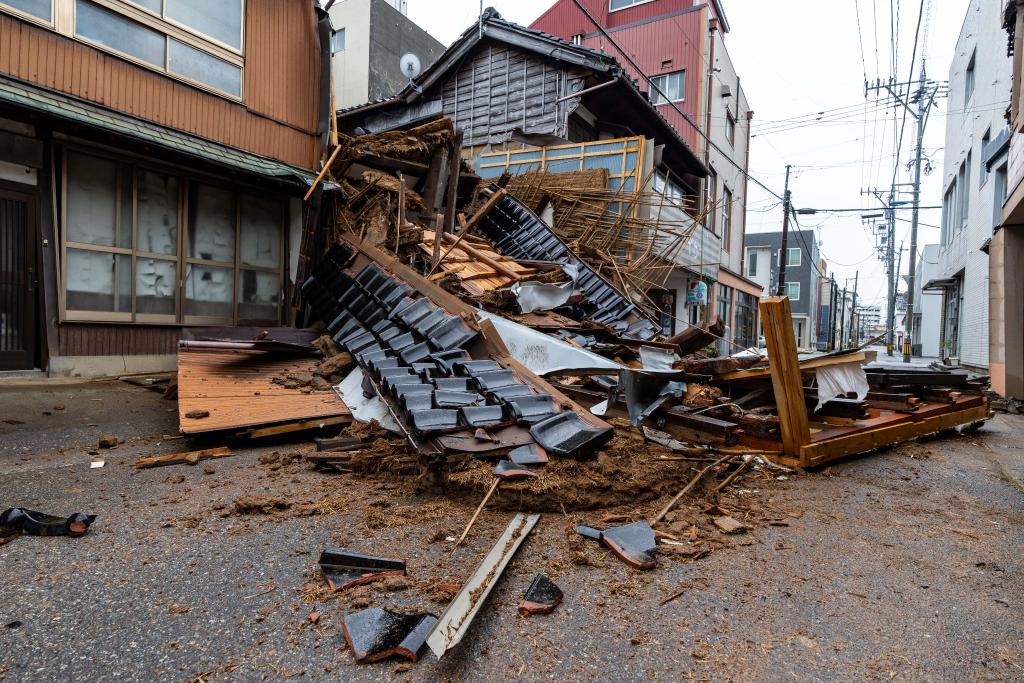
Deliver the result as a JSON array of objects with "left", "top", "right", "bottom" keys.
[{"left": 745, "top": 229, "right": 823, "bottom": 350}]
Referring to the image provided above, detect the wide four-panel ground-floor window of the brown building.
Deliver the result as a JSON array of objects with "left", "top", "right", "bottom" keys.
[{"left": 61, "top": 150, "right": 285, "bottom": 325}]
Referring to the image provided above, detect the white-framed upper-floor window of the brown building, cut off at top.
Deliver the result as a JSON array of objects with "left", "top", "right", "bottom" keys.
[{"left": 0, "top": 0, "right": 245, "bottom": 99}]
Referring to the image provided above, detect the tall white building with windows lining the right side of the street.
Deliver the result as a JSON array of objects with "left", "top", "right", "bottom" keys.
[{"left": 924, "top": 0, "right": 1020, "bottom": 369}]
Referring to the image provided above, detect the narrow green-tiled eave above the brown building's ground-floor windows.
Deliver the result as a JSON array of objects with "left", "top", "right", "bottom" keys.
[{"left": 0, "top": 76, "right": 315, "bottom": 186}]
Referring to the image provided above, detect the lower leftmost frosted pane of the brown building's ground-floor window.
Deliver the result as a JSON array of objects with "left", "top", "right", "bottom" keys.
[{"left": 67, "top": 248, "right": 131, "bottom": 313}]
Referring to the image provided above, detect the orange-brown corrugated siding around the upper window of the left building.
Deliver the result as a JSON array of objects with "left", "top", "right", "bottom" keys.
[{"left": 0, "top": 7, "right": 318, "bottom": 168}]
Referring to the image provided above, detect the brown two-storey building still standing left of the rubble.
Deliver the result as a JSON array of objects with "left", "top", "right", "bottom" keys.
[{"left": 0, "top": 0, "right": 330, "bottom": 376}]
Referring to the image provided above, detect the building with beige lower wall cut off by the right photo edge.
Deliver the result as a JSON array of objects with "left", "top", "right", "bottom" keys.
[{"left": 984, "top": 0, "right": 1024, "bottom": 399}]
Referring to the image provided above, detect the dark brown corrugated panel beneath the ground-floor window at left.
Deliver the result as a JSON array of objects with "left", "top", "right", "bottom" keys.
[{"left": 57, "top": 323, "right": 181, "bottom": 355}]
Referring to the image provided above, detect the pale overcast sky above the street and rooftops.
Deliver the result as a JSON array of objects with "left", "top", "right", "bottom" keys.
[{"left": 409, "top": 0, "right": 974, "bottom": 303}]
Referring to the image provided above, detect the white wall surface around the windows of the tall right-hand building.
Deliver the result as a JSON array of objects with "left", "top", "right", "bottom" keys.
[{"left": 938, "top": 0, "right": 1012, "bottom": 368}]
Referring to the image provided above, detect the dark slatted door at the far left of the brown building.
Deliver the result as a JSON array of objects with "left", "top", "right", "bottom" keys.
[{"left": 0, "top": 187, "right": 39, "bottom": 370}]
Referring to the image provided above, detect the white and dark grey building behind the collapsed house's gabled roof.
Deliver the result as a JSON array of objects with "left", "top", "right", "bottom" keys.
[{"left": 328, "top": 0, "right": 444, "bottom": 109}]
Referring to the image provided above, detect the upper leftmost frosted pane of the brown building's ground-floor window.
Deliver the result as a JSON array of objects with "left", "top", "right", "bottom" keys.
[{"left": 68, "top": 153, "right": 131, "bottom": 249}]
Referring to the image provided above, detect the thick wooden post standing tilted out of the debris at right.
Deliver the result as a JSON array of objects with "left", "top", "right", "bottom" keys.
[{"left": 760, "top": 296, "right": 811, "bottom": 466}]
